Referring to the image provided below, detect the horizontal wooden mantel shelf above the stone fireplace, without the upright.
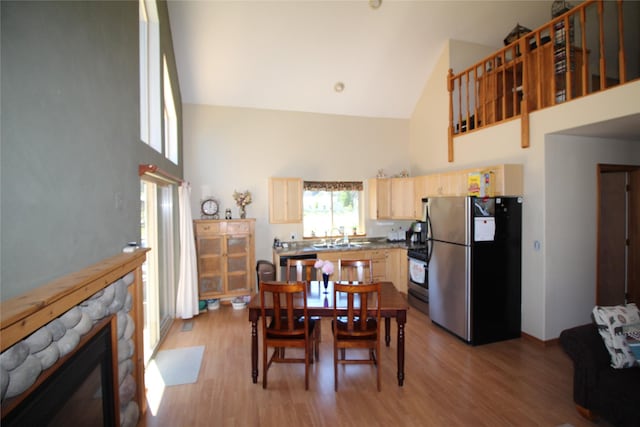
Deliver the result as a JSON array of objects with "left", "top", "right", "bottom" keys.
[{"left": 0, "top": 249, "right": 149, "bottom": 352}]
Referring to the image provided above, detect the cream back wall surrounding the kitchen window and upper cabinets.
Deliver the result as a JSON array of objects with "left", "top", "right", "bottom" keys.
[{"left": 183, "top": 104, "right": 409, "bottom": 260}]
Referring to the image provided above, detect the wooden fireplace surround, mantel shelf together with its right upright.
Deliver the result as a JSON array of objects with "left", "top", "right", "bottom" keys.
[{"left": 0, "top": 249, "right": 149, "bottom": 422}]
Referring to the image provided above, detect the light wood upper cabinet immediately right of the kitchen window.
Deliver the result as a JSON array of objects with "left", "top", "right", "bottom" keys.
[{"left": 368, "top": 178, "right": 415, "bottom": 219}]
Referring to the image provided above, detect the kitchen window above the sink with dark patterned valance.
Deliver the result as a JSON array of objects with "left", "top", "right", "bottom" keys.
[{"left": 302, "top": 181, "right": 365, "bottom": 237}]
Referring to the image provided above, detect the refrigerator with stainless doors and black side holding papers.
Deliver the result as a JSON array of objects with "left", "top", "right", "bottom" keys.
[{"left": 427, "top": 196, "right": 522, "bottom": 345}]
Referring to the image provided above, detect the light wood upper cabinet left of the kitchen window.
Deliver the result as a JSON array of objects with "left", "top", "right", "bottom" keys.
[{"left": 269, "top": 177, "right": 302, "bottom": 224}]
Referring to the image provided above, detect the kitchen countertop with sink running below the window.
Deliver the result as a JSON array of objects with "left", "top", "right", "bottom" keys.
[{"left": 273, "top": 237, "right": 424, "bottom": 256}]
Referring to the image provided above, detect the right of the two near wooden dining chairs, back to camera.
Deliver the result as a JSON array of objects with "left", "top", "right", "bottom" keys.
[{"left": 331, "top": 283, "right": 380, "bottom": 391}]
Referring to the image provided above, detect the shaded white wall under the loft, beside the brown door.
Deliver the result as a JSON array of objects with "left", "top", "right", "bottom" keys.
[{"left": 545, "top": 135, "right": 640, "bottom": 337}]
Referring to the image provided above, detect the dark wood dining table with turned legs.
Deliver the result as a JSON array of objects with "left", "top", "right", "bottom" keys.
[{"left": 248, "top": 280, "right": 409, "bottom": 386}]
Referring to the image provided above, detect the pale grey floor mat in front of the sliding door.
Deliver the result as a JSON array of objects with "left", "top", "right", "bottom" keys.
[{"left": 154, "top": 345, "right": 204, "bottom": 386}]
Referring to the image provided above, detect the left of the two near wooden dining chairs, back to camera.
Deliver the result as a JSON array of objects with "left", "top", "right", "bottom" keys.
[{"left": 260, "top": 282, "right": 314, "bottom": 390}]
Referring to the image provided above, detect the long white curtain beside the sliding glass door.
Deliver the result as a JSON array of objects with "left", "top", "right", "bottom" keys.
[{"left": 176, "top": 182, "right": 199, "bottom": 319}]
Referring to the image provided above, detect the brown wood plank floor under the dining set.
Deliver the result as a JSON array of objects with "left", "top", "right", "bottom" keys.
[{"left": 139, "top": 306, "right": 608, "bottom": 427}]
